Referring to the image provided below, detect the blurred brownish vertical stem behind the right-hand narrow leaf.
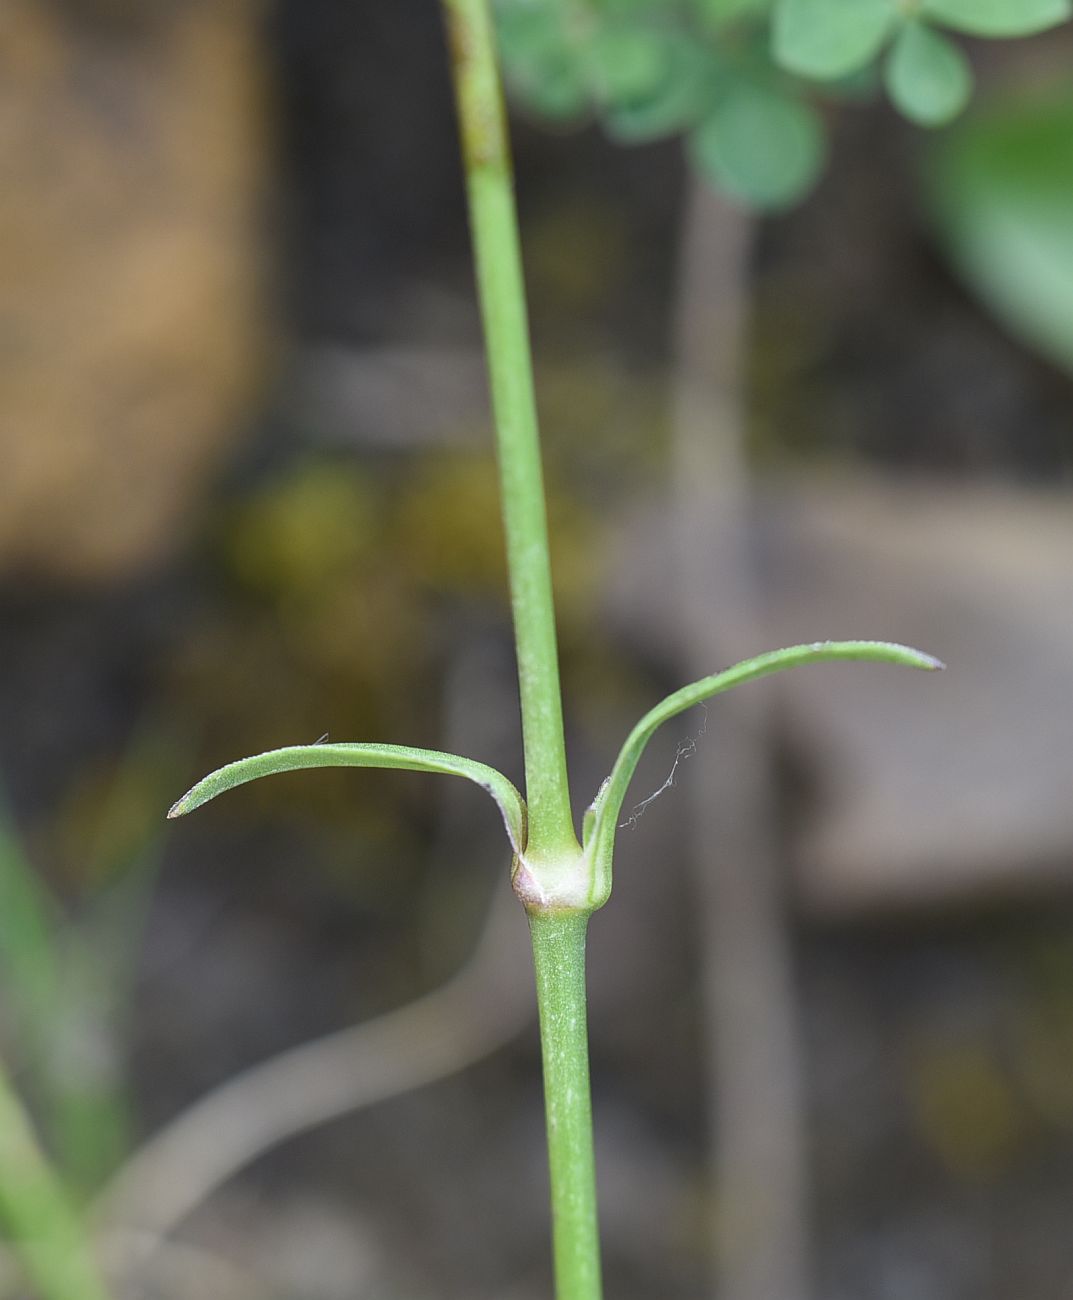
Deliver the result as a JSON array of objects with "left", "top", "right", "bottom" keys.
[{"left": 672, "top": 176, "right": 809, "bottom": 1300}]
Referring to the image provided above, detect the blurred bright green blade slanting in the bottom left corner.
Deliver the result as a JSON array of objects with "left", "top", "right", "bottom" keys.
[{"left": 0, "top": 1070, "right": 108, "bottom": 1300}]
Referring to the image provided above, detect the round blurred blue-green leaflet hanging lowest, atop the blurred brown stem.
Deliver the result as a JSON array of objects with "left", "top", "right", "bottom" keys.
[{"left": 689, "top": 83, "right": 825, "bottom": 209}]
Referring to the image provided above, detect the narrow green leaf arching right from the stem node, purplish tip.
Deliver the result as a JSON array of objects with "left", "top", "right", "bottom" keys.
[{"left": 585, "top": 641, "right": 943, "bottom": 889}]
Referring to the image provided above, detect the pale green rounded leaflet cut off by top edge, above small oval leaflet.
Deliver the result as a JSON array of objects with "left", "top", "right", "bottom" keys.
[{"left": 773, "top": 0, "right": 899, "bottom": 81}]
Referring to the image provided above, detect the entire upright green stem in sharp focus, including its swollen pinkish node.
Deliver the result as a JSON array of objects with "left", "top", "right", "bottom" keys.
[{"left": 444, "top": 0, "right": 601, "bottom": 1300}]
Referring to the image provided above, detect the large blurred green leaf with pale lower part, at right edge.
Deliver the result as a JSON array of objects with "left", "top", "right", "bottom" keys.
[{"left": 926, "top": 90, "right": 1073, "bottom": 372}]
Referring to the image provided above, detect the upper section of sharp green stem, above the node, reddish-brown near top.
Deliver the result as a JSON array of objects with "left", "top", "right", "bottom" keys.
[{"left": 444, "top": 0, "right": 577, "bottom": 862}]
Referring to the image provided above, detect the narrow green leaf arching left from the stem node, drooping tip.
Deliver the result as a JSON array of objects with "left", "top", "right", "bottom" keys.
[{"left": 168, "top": 744, "right": 528, "bottom": 854}]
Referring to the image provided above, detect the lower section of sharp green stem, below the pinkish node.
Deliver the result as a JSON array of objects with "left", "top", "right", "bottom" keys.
[{"left": 529, "top": 911, "right": 601, "bottom": 1300}]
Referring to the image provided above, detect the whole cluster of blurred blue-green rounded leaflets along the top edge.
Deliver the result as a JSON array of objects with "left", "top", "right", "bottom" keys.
[{"left": 496, "top": 0, "right": 1070, "bottom": 209}]
